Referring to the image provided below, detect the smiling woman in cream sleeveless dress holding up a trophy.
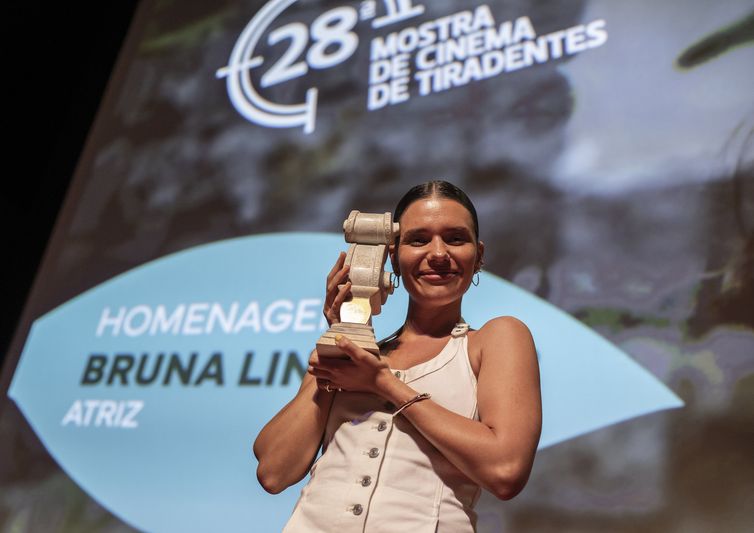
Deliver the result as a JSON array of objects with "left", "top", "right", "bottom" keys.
[{"left": 254, "top": 181, "right": 541, "bottom": 533}]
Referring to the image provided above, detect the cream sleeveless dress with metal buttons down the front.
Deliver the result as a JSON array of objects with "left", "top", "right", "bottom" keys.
[{"left": 283, "top": 324, "right": 480, "bottom": 533}]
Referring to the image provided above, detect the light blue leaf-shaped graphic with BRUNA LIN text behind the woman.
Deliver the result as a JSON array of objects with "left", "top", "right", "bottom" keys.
[{"left": 9, "top": 234, "right": 681, "bottom": 532}]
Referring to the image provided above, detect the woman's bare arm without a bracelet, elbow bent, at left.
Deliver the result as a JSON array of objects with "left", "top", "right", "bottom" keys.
[{"left": 254, "top": 360, "right": 334, "bottom": 494}]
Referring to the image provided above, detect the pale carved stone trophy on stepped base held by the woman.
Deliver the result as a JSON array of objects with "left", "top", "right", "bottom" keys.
[{"left": 317, "top": 210, "right": 399, "bottom": 357}]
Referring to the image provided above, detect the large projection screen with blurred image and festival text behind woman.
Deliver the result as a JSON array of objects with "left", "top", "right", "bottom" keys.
[{"left": 0, "top": 0, "right": 754, "bottom": 532}]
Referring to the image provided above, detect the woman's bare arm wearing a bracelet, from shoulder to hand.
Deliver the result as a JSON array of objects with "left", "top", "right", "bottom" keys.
[{"left": 314, "top": 317, "right": 542, "bottom": 500}]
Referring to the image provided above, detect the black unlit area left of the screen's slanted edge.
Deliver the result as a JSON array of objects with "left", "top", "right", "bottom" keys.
[{"left": 0, "top": 0, "right": 139, "bottom": 370}]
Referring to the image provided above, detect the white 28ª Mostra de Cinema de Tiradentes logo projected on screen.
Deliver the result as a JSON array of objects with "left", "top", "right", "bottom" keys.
[{"left": 215, "top": 0, "right": 607, "bottom": 133}]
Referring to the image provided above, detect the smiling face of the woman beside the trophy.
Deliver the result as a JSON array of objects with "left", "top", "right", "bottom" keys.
[{"left": 391, "top": 197, "right": 484, "bottom": 305}]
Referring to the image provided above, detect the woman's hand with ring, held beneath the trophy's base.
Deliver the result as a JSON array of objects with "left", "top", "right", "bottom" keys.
[{"left": 308, "top": 335, "right": 390, "bottom": 394}]
